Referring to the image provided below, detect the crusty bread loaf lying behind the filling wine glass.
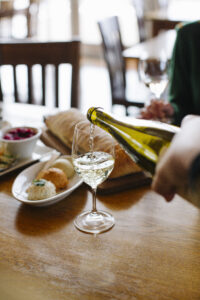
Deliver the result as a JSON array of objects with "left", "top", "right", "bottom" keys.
[{"left": 45, "top": 108, "right": 142, "bottom": 178}]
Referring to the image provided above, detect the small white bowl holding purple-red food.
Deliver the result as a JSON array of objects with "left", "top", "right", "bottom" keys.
[{"left": 0, "top": 126, "right": 42, "bottom": 159}]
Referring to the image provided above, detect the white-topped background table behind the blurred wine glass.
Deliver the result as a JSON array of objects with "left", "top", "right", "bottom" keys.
[{"left": 123, "top": 30, "right": 176, "bottom": 60}]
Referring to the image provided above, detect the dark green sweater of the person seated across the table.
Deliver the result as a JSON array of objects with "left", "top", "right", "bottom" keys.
[{"left": 169, "top": 21, "right": 200, "bottom": 125}]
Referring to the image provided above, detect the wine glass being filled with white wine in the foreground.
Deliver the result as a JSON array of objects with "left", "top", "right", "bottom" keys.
[{"left": 72, "top": 121, "right": 115, "bottom": 234}]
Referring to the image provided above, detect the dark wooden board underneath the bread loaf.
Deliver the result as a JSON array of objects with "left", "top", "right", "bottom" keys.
[{"left": 41, "top": 128, "right": 151, "bottom": 194}]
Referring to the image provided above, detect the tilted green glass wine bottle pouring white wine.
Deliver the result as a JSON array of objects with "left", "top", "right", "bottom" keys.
[{"left": 87, "top": 107, "right": 180, "bottom": 175}]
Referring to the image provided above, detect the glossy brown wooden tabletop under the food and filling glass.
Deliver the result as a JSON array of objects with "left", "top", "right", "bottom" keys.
[{"left": 0, "top": 104, "right": 200, "bottom": 300}]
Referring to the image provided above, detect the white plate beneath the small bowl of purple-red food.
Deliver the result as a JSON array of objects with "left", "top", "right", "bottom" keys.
[{"left": 0, "top": 141, "right": 55, "bottom": 177}]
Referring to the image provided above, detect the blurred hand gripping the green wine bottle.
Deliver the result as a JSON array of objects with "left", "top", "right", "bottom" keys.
[{"left": 152, "top": 116, "right": 200, "bottom": 201}]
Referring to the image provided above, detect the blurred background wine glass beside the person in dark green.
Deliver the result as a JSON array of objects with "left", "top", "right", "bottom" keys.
[{"left": 138, "top": 56, "right": 168, "bottom": 100}]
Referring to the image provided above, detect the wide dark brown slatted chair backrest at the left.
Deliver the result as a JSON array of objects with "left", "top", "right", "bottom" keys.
[{"left": 0, "top": 39, "right": 80, "bottom": 107}]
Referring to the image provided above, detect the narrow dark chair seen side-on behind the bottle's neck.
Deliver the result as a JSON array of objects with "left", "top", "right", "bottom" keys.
[{"left": 98, "top": 16, "right": 144, "bottom": 115}]
